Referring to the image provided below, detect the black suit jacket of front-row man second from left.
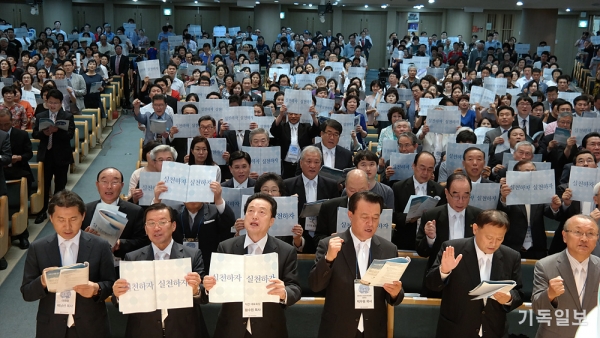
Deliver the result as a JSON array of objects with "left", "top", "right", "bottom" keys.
[{"left": 117, "top": 242, "right": 208, "bottom": 338}]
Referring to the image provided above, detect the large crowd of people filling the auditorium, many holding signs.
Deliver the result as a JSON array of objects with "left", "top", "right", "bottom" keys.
[{"left": 0, "top": 14, "right": 600, "bottom": 337}]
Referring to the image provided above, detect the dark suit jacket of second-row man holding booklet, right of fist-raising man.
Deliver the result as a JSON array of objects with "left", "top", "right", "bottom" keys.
[{"left": 392, "top": 177, "right": 446, "bottom": 250}]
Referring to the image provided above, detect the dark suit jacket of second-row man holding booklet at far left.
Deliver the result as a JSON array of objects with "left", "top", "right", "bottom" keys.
[{"left": 81, "top": 199, "right": 150, "bottom": 258}]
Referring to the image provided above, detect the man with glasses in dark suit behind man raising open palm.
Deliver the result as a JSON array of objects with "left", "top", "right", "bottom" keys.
[{"left": 416, "top": 174, "right": 482, "bottom": 298}]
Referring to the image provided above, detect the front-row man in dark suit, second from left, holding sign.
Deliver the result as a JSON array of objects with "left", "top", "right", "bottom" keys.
[{"left": 112, "top": 203, "right": 208, "bottom": 338}]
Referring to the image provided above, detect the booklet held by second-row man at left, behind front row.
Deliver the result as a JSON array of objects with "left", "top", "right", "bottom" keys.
[{"left": 90, "top": 203, "right": 127, "bottom": 247}]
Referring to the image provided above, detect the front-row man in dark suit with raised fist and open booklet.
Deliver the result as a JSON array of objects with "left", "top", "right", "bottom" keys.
[{"left": 308, "top": 191, "right": 404, "bottom": 338}]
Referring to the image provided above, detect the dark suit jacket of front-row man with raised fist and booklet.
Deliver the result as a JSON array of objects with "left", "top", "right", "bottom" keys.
[{"left": 308, "top": 229, "right": 404, "bottom": 338}]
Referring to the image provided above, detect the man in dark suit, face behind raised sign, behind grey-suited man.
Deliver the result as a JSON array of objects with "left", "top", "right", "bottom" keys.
[{"left": 498, "top": 161, "right": 562, "bottom": 259}]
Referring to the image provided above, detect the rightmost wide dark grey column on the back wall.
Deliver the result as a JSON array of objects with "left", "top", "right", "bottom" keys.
[{"left": 517, "top": 8, "right": 558, "bottom": 53}]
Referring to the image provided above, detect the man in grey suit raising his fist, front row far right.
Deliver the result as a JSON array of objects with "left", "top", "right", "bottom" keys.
[{"left": 531, "top": 215, "right": 600, "bottom": 338}]
